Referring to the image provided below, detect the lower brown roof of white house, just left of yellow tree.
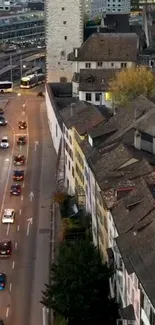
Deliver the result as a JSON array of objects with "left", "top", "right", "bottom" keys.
[{"left": 79, "top": 69, "right": 121, "bottom": 91}]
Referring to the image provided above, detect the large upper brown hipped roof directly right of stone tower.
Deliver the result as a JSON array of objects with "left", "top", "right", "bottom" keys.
[{"left": 68, "top": 33, "right": 138, "bottom": 62}]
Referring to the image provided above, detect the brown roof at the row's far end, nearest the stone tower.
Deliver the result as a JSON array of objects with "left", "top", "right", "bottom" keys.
[{"left": 60, "top": 101, "right": 105, "bottom": 135}]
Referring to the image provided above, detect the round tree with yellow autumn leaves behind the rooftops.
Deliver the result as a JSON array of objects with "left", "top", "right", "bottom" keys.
[{"left": 109, "top": 66, "right": 155, "bottom": 104}]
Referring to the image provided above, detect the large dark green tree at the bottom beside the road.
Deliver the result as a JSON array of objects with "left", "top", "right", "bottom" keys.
[{"left": 42, "top": 240, "right": 117, "bottom": 325}]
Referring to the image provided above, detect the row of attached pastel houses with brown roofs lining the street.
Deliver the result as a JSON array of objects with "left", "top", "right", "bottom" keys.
[{"left": 47, "top": 78, "right": 155, "bottom": 325}]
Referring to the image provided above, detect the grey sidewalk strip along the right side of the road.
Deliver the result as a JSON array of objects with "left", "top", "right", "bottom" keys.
[{"left": 30, "top": 104, "right": 56, "bottom": 325}]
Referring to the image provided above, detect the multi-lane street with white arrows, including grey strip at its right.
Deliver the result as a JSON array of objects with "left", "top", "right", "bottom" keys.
[{"left": 0, "top": 93, "right": 56, "bottom": 325}]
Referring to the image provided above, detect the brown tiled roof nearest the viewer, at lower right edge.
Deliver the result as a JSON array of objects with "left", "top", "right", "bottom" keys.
[{"left": 116, "top": 214, "right": 155, "bottom": 306}]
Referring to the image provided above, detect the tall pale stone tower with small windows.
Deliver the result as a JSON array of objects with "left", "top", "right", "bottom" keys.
[{"left": 45, "top": 0, "right": 84, "bottom": 82}]
